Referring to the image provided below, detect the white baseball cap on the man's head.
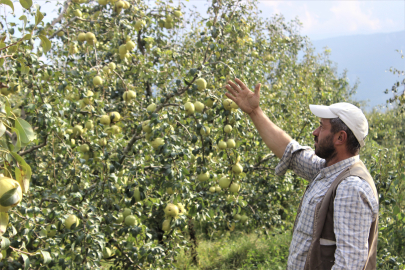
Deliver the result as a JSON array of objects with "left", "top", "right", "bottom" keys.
[{"left": 309, "top": 102, "right": 368, "bottom": 147}]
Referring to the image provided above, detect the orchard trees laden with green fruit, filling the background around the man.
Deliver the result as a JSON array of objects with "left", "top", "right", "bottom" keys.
[{"left": 0, "top": 0, "right": 404, "bottom": 269}]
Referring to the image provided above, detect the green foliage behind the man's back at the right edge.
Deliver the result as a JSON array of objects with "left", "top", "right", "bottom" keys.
[{"left": 363, "top": 92, "right": 405, "bottom": 269}]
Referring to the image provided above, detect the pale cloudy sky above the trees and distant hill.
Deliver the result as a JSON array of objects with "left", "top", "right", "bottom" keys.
[{"left": 6, "top": 0, "right": 405, "bottom": 40}]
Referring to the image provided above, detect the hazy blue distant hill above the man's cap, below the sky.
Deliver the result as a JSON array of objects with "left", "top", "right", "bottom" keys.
[{"left": 312, "top": 31, "right": 405, "bottom": 110}]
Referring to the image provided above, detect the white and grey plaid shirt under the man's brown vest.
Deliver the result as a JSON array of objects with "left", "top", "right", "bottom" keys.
[{"left": 276, "top": 141, "right": 378, "bottom": 270}]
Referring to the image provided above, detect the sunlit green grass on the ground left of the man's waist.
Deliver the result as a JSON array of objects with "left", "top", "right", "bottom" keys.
[{"left": 175, "top": 231, "right": 291, "bottom": 270}]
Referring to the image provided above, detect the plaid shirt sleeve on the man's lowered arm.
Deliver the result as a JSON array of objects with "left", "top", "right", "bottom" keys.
[{"left": 332, "top": 176, "right": 378, "bottom": 270}]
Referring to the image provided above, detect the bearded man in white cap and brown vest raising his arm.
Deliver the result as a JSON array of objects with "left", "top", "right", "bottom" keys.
[{"left": 226, "top": 79, "right": 378, "bottom": 270}]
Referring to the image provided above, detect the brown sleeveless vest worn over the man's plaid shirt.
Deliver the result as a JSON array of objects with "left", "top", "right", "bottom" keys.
[{"left": 294, "top": 161, "right": 378, "bottom": 270}]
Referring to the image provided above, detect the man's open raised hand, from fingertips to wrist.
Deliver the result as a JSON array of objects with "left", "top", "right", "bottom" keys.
[{"left": 225, "top": 79, "right": 260, "bottom": 115}]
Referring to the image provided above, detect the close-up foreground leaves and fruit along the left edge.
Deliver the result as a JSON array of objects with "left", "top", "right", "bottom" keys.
[{"left": 0, "top": 0, "right": 42, "bottom": 266}]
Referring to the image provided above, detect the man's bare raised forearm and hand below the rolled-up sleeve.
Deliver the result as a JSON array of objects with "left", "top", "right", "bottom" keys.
[{"left": 225, "top": 79, "right": 292, "bottom": 158}]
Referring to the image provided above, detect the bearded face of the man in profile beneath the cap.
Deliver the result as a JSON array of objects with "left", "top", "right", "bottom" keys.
[{"left": 312, "top": 118, "right": 336, "bottom": 160}]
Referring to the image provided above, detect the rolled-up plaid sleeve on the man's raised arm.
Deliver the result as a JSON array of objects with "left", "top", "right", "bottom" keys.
[{"left": 275, "top": 140, "right": 325, "bottom": 181}]
